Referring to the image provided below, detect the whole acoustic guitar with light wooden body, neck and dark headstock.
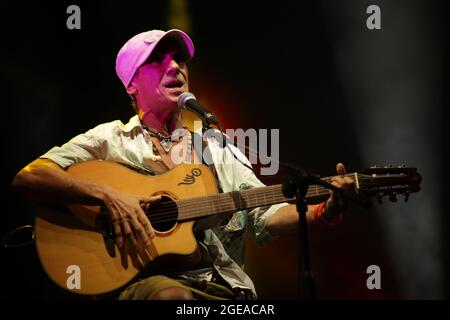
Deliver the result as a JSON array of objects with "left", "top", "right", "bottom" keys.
[{"left": 35, "top": 161, "right": 421, "bottom": 295}]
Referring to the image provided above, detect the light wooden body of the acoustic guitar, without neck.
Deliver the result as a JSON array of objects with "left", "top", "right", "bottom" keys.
[{"left": 35, "top": 161, "right": 218, "bottom": 295}]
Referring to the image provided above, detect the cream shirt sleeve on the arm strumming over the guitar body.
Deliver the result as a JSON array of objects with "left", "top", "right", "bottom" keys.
[{"left": 39, "top": 124, "right": 108, "bottom": 169}]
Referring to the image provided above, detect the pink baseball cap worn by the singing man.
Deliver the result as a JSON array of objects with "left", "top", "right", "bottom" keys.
[{"left": 116, "top": 29, "right": 194, "bottom": 88}]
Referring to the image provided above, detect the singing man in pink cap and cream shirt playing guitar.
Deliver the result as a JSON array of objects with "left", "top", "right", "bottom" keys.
[{"left": 13, "top": 30, "right": 354, "bottom": 299}]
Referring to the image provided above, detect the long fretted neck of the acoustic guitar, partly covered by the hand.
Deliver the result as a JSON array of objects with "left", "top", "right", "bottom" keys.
[{"left": 176, "top": 177, "right": 352, "bottom": 221}]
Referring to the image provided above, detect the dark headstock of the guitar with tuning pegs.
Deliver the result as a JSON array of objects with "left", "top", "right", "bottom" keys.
[{"left": 356, "top": 166, "right": 422, "bottom": 203}]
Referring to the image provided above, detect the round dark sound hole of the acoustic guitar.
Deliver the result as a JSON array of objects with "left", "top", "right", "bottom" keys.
[{"left": 147, "top": 196, "right": 178, "bottom": 232}]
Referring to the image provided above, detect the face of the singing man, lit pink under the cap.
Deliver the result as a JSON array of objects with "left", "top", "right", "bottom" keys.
[{"left": 131, "top": 39, "right": 189, "bottom": 113}]
